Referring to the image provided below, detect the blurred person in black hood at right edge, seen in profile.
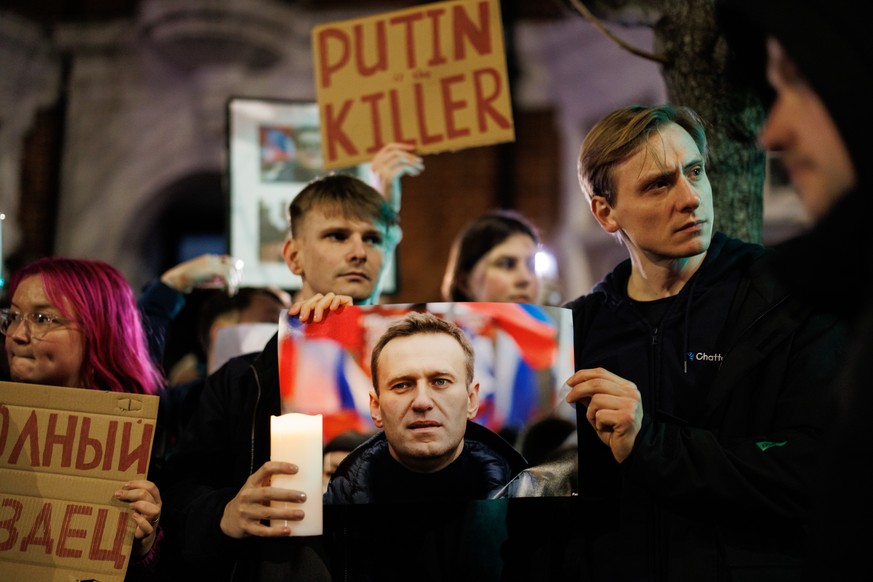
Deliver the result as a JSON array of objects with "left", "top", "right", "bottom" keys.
[{"left": 718, "top": 0, "right": 873, "bottom": 580}]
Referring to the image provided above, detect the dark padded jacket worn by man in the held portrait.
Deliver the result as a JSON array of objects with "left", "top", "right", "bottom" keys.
[{"left": 324, "top": 420, "right": 527, "bottom": 504}]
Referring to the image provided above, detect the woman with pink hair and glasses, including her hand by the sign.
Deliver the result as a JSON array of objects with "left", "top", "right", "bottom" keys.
[{"left": 0, "top": 257, "right": 163, "bottom": 580}]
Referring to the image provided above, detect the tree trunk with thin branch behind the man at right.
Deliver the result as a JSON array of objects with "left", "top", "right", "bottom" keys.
[{"left": 562, "top": 0, "right": 766, "bottom": 243}]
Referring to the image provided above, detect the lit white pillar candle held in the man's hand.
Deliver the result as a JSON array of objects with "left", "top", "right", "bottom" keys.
[{"left": 270, "top": 413, "right": 324, "bottom": 536}]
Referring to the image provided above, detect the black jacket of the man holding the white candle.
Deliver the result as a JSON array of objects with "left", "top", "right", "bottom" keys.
[{"left": 160, "top": 336, "right": 330, "bottom": 581}]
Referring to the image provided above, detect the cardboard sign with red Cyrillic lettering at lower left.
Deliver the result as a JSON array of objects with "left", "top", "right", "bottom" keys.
[{"left": 0, "top": 382, "right": 159, "bottom": 582}]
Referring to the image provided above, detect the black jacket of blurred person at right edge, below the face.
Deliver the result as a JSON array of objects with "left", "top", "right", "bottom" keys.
[{"left": 778, "top": 191, "right": 873, "bottom": 582}]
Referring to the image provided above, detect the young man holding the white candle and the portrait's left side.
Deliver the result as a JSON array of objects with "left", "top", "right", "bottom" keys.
[{"left": 162, "top": 154, "right": 424, "bottom": 581}]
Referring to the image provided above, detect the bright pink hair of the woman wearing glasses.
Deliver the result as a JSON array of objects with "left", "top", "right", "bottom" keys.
[{"left": 9, "top": 257, "right": 164, "bottom": 394}]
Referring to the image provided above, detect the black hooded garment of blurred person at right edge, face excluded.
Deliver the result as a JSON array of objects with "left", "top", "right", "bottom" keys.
[{"left": 719, "top": 0, "right": 873, "bottom": 580}]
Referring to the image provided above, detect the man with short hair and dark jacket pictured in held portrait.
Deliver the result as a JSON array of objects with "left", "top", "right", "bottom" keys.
[{"left": 325, "top": 312, "right": 526, "bottom": 504}]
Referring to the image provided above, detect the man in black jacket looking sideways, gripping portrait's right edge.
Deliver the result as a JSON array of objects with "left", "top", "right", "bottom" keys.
[{"left": 567, "top": 104, "right": 844, "bottom": 582}]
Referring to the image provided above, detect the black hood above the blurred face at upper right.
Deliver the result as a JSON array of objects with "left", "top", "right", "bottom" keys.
[{"left": 717, "top": 0, "right": 873, "bottom": 194}]
